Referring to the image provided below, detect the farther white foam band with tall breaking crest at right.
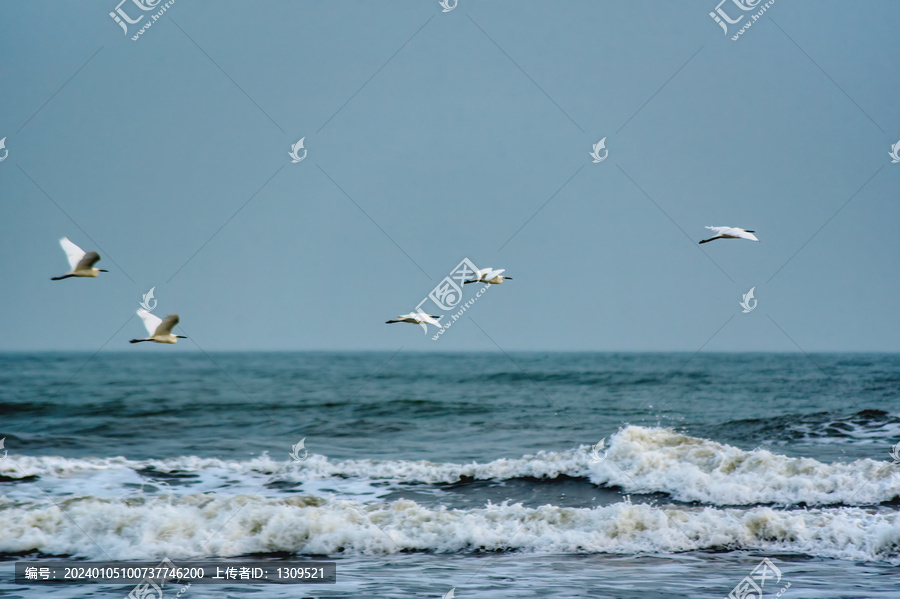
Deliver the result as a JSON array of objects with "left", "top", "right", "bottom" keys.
[{"left": 7, "top": 426, "right": 900, "bottom": 505}]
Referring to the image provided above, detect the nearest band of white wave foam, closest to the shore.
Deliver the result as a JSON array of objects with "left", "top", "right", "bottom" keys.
[{"left": 0, "top": 495, "right": 900, "bottom": 564}]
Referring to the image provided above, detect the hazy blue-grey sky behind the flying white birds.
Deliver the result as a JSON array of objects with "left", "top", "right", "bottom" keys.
[{"left": 0, "top": 0, "right": 900, "bottom": 353}]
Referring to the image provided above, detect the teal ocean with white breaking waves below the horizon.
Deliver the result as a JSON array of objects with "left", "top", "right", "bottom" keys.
[{"left": 0, "top": 347, "right": 900, "bottom": 599}]
